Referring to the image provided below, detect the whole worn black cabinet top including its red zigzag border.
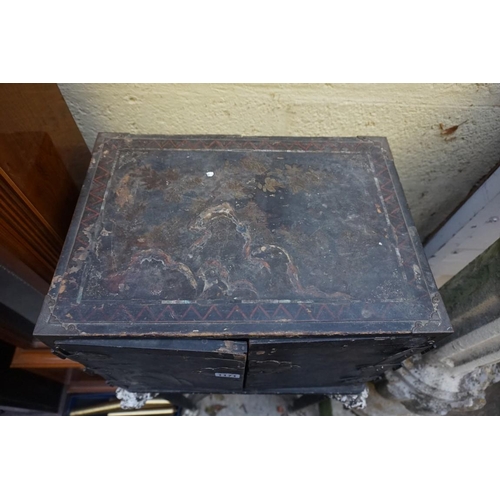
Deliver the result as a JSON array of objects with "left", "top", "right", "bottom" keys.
[{"left": 35, "top": 134, "right": 451, "bottom": 337}]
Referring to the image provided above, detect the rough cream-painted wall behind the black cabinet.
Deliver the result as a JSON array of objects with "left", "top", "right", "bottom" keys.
[{"left": 59, "top": 84, "right": 500, "bottom": 238}]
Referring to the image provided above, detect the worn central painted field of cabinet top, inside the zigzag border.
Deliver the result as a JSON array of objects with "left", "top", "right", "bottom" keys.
[{"left": 89, "top": 150, "right": 406, "bottom": 300}]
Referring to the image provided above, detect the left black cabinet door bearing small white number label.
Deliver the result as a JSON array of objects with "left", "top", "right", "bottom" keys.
[{"left": 55, "top": 339, "right": 247, "bottom": 392}]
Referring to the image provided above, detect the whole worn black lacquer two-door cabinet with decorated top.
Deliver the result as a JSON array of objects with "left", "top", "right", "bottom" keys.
[{"left": 35, "top": 134, "right": 451, "bottom": 393}]
